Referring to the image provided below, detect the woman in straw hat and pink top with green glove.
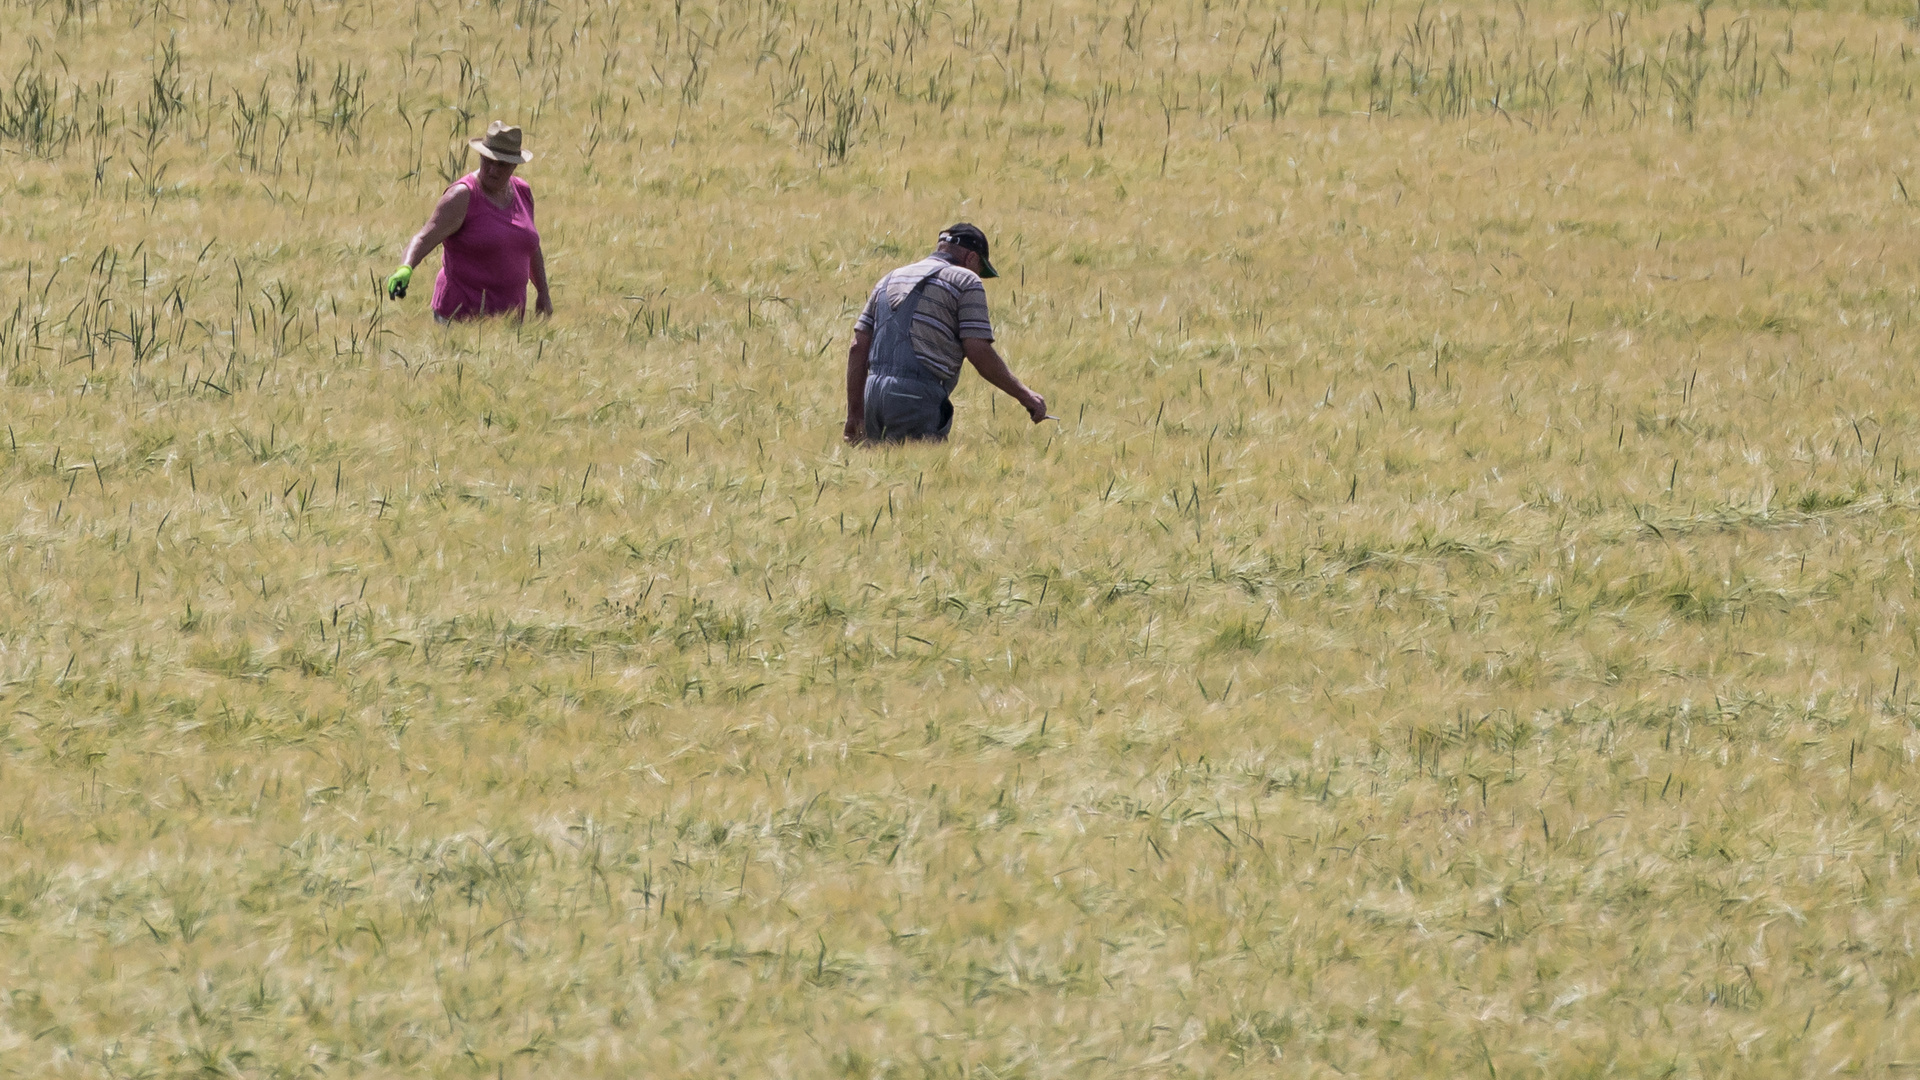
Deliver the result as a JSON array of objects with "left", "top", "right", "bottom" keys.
[{"left": 386, "top": 121, "right": 553, "bottom": 323}]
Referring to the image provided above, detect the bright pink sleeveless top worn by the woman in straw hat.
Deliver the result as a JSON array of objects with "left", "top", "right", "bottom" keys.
[{"left": 434, "top": 173, "right": 540, "bottom": 319}]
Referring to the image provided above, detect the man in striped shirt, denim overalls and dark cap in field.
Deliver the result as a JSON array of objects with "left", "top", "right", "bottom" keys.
[{"left": 847, "top": 221, "right": 1046, "bottom": 442}]
